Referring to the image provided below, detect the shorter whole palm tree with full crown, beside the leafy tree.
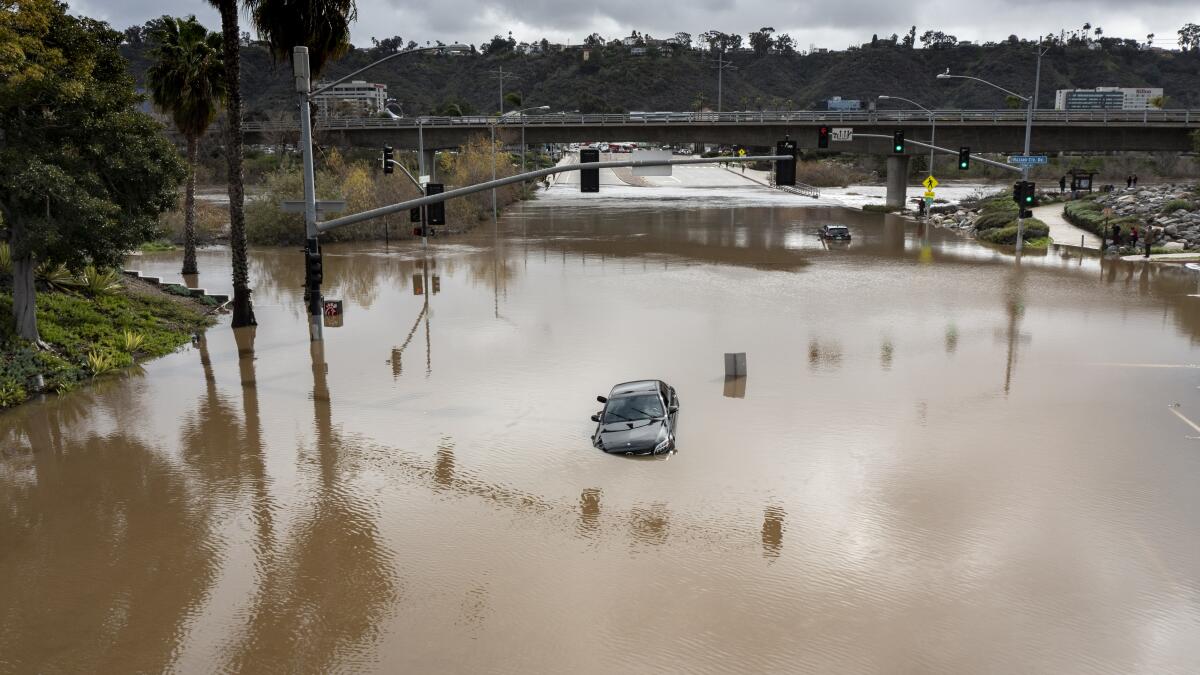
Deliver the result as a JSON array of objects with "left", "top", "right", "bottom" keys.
[{"left": 146, "top": 16, "right": 227, "bottom": 274}]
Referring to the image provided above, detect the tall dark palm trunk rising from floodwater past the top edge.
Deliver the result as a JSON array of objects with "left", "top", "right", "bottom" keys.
[{"left": 218, "top": 0, "right": 258, "bottom": 328}]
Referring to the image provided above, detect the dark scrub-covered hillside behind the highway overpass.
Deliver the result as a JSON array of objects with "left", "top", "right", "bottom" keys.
[{"left": 125, "top": 41, "right": 1200, "bottom": 118}]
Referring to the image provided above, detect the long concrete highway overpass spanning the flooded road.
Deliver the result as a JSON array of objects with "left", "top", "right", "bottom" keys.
[{"left": 244, "top": 109, "right": 1200, "bottom": 154}]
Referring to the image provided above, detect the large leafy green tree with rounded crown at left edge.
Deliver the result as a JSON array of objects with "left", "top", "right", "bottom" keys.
[{"left": 0, "top": 0, "right": 185, "bottom": 341}]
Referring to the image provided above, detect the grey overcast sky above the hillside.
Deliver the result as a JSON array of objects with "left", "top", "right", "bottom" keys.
[{"left": 77, "top": 0, "right": 1200, "bottom": 49}]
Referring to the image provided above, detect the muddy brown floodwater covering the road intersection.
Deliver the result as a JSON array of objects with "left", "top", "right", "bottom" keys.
[{"left": 0, "top": 176, "right": 1200, "bottom": 674}]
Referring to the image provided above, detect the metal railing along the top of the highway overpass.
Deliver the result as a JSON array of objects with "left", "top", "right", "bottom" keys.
[{"left": 242, "top": 109, "right": 1200, "bottom": 132}]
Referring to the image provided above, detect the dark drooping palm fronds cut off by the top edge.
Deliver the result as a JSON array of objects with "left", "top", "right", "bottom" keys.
[{"left": 245, "top": 0, "right": 358, "bottom": 78}]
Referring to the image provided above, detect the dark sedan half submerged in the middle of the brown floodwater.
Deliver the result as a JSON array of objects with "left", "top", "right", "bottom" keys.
[{"left": 592, "top": 380, "right": 679, "bottom": 455}]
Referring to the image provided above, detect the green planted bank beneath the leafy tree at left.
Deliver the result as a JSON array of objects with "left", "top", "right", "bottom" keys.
[{"left": 0, "top": 277, "right": 212, "bottom": 408}]
